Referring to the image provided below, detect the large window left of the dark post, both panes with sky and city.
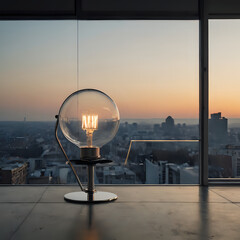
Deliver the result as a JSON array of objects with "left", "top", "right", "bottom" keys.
[{"left": 0, "top": 21, "right": 199, "bottom": 184}]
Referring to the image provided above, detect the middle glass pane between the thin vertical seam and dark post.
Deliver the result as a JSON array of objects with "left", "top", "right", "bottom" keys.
[{"left": 78, "top": 21, "right": 199, "bottom": 184}]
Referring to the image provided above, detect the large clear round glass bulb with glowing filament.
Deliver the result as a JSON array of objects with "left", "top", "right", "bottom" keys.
[{"left": 59, "top": 89, "right": 120, "bottom": 158}]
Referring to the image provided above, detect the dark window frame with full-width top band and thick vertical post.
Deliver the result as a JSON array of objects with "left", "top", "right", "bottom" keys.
[{"left": 0, "top": 0, "right": 240, "bottom": 186}]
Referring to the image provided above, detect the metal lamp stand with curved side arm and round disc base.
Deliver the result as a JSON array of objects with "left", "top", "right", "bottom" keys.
[{"left": 55, "top": 115, "right": 118, "bottom": 203}]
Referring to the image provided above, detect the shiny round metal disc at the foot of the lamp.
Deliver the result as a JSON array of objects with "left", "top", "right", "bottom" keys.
[{"left": 64, "top": 191, "right": 118, "bottom": 203}]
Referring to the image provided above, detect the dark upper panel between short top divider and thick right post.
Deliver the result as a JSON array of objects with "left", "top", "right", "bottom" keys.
[{"left": 81, "top": 0, "right": 198, "bottom": 19}]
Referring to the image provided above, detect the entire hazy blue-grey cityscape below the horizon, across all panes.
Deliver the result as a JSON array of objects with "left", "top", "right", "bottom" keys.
[{"left": 0, "top": 112, "right": 240, "bottom": 184}]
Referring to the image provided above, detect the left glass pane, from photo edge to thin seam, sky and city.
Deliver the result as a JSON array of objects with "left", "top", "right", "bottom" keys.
[{"left": 0, "top": 21, "right": 77, "bottom": 184}]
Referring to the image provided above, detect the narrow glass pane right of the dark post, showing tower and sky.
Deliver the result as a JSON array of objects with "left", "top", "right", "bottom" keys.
[{"left": 209, "top": 20, "right": 240, "bottom": 178}]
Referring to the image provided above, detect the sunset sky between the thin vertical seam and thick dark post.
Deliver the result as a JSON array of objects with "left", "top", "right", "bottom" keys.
[{"left": 79, "top": 21, "right": 198, "bottom": 118}]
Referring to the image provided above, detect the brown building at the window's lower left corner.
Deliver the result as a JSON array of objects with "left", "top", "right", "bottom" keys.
[{"left": 0, "top": 163, "right": 28, "bottom": 184}]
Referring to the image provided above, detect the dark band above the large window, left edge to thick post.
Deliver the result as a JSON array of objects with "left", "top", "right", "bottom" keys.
[{"left": 0, "top": 0, "right": 198, "bottom": 19}]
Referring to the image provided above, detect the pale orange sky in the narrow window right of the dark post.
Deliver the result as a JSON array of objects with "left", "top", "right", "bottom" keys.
[{"left": 209, "top": 20, "right": 240, "bottom": 118}]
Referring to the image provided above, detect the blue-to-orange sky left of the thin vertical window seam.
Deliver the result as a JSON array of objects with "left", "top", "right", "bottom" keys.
[{"left": 0, "top": 21, "right": 77, "bottom": 120}]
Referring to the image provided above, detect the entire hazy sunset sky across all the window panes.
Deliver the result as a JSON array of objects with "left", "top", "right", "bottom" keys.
[{"left": 0, "top": 20, "right": 240, "bottom": 121}]
